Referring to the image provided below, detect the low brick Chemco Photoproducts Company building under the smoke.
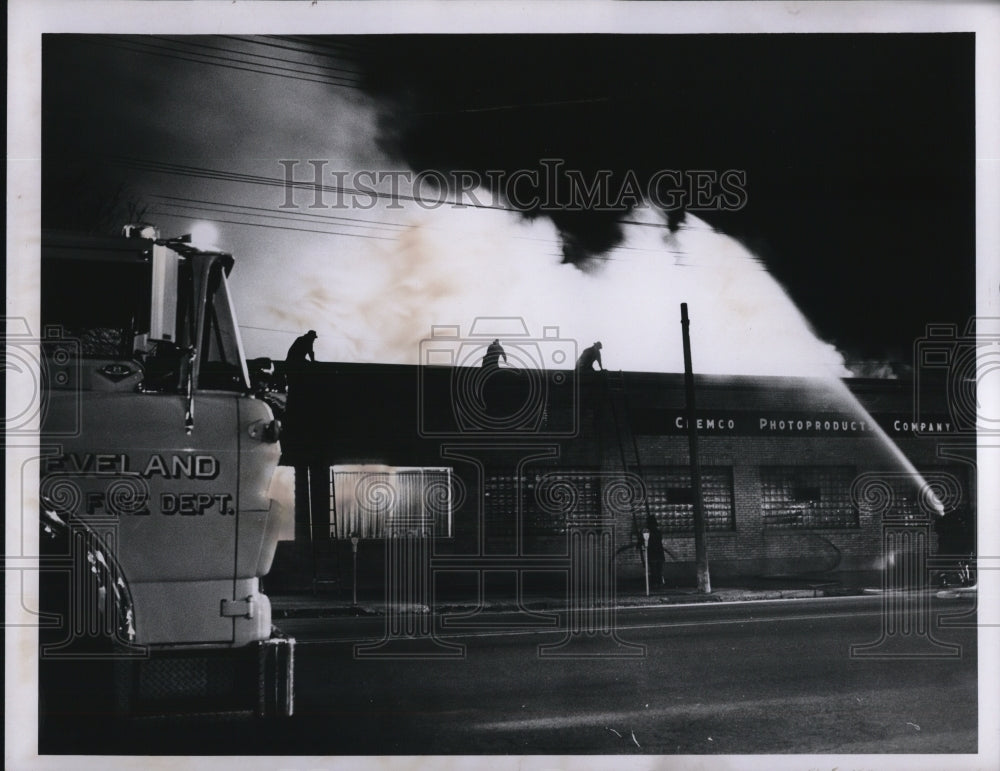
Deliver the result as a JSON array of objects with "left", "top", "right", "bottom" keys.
[{"left": 279, "top": 364, "right": 975, "bottom": 582}]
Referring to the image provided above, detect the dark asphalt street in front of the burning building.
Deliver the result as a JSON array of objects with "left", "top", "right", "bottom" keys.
[{"left": 60, "top": 592, "right": 978, "bottom": 756}]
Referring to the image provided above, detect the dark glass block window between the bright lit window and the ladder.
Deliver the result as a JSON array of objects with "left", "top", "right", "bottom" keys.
[{"left": 483, "top": 468, "right": 601, "bottom": 538}]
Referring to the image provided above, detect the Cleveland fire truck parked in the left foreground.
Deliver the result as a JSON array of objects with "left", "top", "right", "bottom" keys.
[{"left": 39, "top": 225, "right": 295, "bottom": 719}]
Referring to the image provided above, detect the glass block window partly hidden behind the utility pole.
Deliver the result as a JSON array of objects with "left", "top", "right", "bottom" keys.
[{"left": 643, "top": 466, "right": 735, "bottom": 535}]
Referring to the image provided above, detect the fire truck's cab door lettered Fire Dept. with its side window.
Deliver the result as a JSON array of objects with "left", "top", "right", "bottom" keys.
[{"left": 40, "top": 238, "right": 249, "bottom": 646}]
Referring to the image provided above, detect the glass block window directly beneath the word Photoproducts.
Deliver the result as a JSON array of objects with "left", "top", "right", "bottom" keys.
[{"left": 760, "top": 466, "right": 858, "bottom": 528}]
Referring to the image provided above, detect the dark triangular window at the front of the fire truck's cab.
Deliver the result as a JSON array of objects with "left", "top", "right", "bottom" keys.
[{"left": 198, "top": 263, "right": 250, "bottom": 391}]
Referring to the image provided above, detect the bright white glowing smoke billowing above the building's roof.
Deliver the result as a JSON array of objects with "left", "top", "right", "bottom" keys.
[{"left": 246, "top": 196, "right": 847, "bottom": 376}]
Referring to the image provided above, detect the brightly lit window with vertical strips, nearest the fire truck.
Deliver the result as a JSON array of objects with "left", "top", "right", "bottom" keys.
[{"left": 330, "top": 466, "right": 454, "bottom": 538}]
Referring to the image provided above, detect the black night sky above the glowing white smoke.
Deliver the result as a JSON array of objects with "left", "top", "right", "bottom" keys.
[{"left": 43, "top": 33, "right": 975, "bottom": 372}]
